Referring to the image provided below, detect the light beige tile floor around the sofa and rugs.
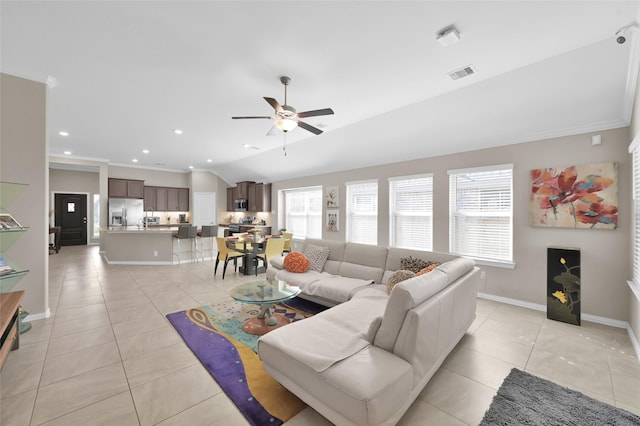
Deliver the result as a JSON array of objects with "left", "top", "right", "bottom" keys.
[{"left": 0, "top": 246, "right": 640, "bottom": 426}]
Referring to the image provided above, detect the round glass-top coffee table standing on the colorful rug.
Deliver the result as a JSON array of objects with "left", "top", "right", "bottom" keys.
[{"left": 231, "top": 280, "right": 300, "bottom": 336}]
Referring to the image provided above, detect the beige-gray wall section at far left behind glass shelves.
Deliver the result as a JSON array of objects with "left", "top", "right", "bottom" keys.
[{"left": 0, "top": 74, "right": 49, "bottom": 315}]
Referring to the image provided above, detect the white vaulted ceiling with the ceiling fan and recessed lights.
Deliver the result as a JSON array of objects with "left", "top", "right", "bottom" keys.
[{"left": 0, "top": 0, "right": 640, "bottom": 183}]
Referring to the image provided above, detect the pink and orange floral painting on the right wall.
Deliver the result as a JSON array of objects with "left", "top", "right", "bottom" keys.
[{"left": 529, "top": 163, "right": 618, "bottom": 229}]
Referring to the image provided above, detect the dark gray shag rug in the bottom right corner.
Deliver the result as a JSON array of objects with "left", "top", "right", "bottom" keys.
[{"left": 480, "top": 368, "right": 640, "bottom": 426}]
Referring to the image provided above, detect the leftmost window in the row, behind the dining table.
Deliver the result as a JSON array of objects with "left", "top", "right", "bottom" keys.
[{"left": 284, "top": 186, "right": 322, "bottom": 238}]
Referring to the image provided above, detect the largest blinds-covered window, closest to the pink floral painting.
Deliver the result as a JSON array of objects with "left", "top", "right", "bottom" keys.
[{"left": 449, "top": 164, "right": 513, "bottom": 263}]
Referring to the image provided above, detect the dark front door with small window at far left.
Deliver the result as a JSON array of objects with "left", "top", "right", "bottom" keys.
[{"left": 55, "top": 194, "right": 87, "bottom": 246}]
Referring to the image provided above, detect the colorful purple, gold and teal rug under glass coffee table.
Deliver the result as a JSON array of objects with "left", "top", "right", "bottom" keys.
[{"left": 167, "top": 298, "right": 326, "bottom": 426}]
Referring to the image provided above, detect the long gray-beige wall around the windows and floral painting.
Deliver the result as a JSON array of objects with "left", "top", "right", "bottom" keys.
[{"left": 273, "top": 128, "right": 631, "bottom": 321}]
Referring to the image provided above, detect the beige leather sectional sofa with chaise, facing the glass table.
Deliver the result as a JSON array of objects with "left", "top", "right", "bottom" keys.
[{"left": 258, "top": 240, "right": 480, "bottom": 425}]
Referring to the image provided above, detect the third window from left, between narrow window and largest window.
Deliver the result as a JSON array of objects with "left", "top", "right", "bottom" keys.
[{"left": 389, "top": 174, "right": 433, "bottom": 250}]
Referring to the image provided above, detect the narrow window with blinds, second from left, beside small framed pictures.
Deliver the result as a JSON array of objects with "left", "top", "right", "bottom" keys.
[{"left": 346, "top": 181, "right": 378, "bottom": 244}]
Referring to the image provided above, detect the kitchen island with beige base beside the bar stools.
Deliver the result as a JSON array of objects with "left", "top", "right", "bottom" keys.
[{"left": 100, "top": 225, "right": 196, "bottom": 265}]
